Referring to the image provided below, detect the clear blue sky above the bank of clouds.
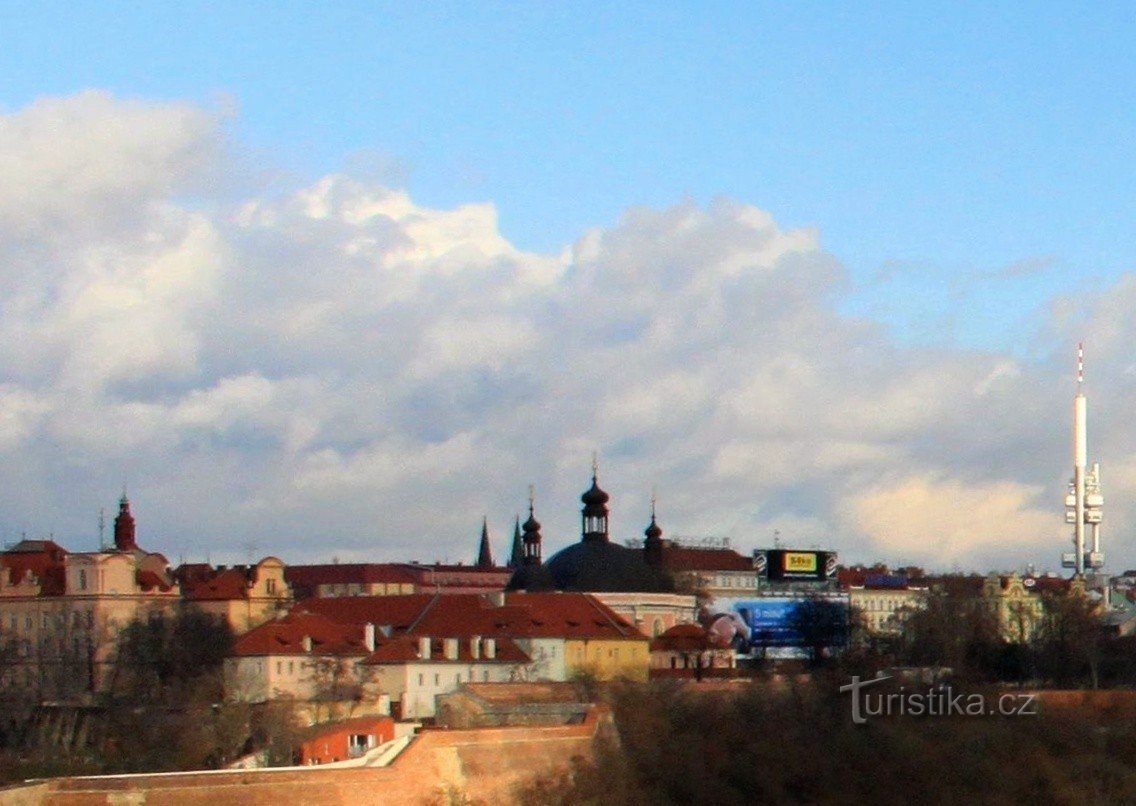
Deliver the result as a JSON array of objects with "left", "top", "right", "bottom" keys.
[{"left": 13, "top": 2, "right": 1136, "bottom": 350}]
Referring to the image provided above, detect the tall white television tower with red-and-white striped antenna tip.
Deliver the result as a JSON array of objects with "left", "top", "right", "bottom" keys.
[{"left": 1061, "top": 344, "right": 1104, "bottom": 577}]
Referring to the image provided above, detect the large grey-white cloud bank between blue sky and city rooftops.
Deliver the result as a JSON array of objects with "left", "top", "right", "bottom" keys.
[{"left": 0, "top": 92, "right": 1117, "bottom": 568}]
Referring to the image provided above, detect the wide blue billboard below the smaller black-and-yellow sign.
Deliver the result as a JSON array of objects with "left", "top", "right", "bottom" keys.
[{"left": 703, "top": 594, "right": 849, "bottom": 656}]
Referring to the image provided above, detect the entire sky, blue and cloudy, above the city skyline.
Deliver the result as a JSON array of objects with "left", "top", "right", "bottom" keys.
[{"left": 0, "top": 1, "right": 1136, "bottom": 571}]
